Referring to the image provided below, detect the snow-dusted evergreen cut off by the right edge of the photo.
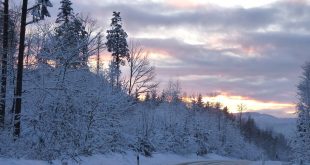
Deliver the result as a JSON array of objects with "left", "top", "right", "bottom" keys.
[{"left": 294, "top": 63, "right": 310, "bottom": 164}]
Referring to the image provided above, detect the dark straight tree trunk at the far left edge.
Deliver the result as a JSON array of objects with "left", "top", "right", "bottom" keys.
[{"left": 0, "top": 0, "right": 9, "bottom": 128}]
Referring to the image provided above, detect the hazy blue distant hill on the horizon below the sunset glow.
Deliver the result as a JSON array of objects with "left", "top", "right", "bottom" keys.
[{"left": 236, "top": 112, "right": 296, "bottom": 138}]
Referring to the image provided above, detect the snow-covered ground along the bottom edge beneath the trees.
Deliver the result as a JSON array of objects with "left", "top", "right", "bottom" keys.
[{"left": 0, "top": 153, "right": 282, "bottom": 165}]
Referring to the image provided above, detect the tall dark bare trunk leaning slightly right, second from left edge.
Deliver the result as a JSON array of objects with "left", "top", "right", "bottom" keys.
[{"left": 13, "top": 0, "right": 28, "bottom": 139}]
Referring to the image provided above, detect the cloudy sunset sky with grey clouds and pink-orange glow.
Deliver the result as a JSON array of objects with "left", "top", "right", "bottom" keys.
[{"left": 26, "top": 0, "right": 310, "bottom": 117}]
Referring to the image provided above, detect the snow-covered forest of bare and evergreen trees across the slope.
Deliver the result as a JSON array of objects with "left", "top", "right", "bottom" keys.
[{"left": 0, "top": 0, "right": 310, "bottom": 162}]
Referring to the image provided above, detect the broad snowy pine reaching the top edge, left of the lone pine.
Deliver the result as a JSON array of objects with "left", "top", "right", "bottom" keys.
[{"left": 54, "top": 0, "right": 88, "bottom": 68}]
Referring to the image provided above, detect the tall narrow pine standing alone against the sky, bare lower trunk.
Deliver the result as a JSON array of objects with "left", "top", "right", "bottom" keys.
[{"left": 106, "top": 11, "right": 129, "bottom": 87}]
